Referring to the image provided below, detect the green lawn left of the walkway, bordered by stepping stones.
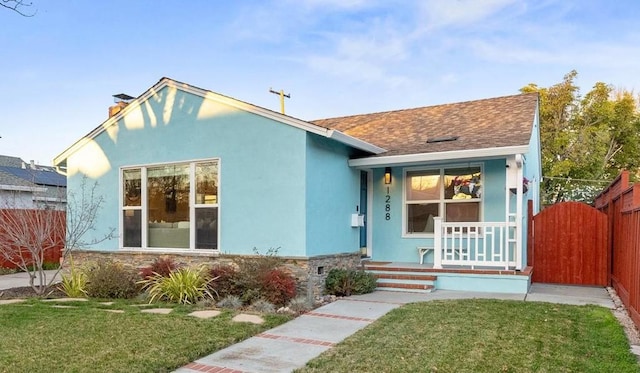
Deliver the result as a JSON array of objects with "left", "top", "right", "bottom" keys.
[{"left": 0, "top": 300, "right": 290, "bottom": 372}]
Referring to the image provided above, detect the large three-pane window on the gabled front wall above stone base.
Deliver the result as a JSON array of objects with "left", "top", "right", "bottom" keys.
[{"left": 121, "top": 160, "right": 218, "bottom": 250}]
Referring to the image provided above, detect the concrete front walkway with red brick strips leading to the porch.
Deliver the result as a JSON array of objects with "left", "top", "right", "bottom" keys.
[{"left": 175, "top": 284, "right": 615, "bottom": 373}]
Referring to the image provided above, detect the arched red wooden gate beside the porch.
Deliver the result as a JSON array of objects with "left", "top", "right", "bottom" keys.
[{"left": 528, "top": 202, "right": 609, "bottom": 286}]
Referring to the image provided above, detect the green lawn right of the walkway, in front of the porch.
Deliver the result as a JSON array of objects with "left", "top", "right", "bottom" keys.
[{"left": 297, "top": 299, "right": 640, "bottom": 373}]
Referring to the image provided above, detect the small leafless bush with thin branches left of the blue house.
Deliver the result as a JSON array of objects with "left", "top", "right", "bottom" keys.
[{"left": 0, "top": 177, "right": 115, "bottom": 295}]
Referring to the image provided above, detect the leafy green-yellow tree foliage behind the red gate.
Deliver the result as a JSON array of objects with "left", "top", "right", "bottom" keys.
[{"left": 520, "top": 70, "right": 640, "bottom": 204}]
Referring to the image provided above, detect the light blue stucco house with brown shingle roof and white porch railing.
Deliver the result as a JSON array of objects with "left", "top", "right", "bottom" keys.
[{"left": 54, "top": 78, "right": 541, "bottom": 292}]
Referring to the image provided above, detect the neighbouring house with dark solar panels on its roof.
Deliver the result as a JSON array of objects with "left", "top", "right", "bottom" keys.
[{"left": 0, "top": 155, "right": 67, "bottom": 210}]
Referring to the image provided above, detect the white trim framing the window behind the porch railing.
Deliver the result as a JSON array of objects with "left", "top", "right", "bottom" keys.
[{"left": 401, "top": 162, "right": 486, "bottom": 239}]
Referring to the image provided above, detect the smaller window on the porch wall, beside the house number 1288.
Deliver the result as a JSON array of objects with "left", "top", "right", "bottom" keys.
[{"left": 404, "top": 166, "right": 482, "bottom": 235}]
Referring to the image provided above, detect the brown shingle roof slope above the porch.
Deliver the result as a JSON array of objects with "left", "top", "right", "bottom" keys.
[{"left": 312, "top": 93, "right": 538, "bottom": 156}]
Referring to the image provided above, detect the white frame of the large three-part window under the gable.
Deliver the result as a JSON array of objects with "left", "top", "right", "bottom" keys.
[{"left": 118, "top": 158, "right": 222, "bottom": 254}]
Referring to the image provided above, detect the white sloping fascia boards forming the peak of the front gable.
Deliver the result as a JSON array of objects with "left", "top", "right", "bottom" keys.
[{"left": 53, "top": 78, "right": 384, "bottom": 163}]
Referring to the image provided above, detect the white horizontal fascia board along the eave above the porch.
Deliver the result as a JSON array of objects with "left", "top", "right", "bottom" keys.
[{"left": 349, "top": 145, "right": 529, "bottom": 168}]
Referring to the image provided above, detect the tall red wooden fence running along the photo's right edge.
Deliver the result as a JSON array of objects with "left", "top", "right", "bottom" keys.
[{"left": 595, "top": 171, "right": 640, "bottom": 328}]
